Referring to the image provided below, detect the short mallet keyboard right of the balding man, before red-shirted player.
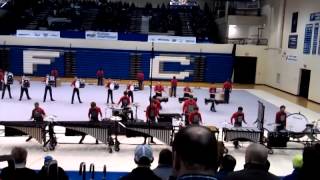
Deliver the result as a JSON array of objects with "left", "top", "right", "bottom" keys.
[{"left": 222, "top": 127, "right": 261, "bottom": 142}]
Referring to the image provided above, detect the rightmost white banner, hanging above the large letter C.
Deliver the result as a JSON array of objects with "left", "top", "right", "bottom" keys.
[{"left": 148, "top": 35, "right": 197, "bottom": 44}]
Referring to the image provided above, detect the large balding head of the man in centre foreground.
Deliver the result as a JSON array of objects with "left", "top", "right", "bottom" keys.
[{"left": 172, "top": 125, "right": 218, "bottom": 180}]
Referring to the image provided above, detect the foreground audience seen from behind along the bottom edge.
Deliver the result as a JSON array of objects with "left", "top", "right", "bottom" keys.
[{"left": 0, "top": 125, "right": 320, "bottom": 180}]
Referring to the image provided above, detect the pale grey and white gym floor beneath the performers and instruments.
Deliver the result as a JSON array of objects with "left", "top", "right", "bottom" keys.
[{"left": 0, "top": 82, "right": 319, "bottom": 176}]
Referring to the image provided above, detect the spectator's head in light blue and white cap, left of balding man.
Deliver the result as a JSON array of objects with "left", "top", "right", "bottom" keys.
[{"left": 134, "top": 144, "right": 153, "bottom": 167}]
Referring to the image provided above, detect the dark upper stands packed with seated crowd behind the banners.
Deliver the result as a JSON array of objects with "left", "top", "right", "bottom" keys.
[{"left": 0, "top": 0, "right": 220, "bottom": 43}]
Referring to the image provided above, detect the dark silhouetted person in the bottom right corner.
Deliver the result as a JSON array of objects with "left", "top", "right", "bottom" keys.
[{"left": 298, "top": 144, "right": 320, "bottom": 180}]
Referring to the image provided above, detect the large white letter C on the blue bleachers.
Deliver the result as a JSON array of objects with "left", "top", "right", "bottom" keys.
[{"left": 150, "top": 56, "right": 190, "bottom": 80}]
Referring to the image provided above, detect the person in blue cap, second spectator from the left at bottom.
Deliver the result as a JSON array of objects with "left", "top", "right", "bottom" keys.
[{"left": 38, "top": 156, "right": 69, "bottom": 180}]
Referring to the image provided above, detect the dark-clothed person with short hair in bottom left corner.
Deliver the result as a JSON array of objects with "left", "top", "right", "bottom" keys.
[{"left": 0, "top": 147, "right": 38, "bottom": 180}]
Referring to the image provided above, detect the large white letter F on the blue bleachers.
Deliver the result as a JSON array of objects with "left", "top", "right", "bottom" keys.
[{"left": 23, "top": 50, "right": 60, "bottom": 74}]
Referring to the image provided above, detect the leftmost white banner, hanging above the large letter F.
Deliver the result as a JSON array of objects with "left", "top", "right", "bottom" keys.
[{"left": 16, "top": 30, "right": 60, "bottom": 38}]
